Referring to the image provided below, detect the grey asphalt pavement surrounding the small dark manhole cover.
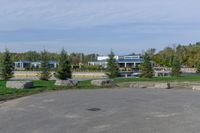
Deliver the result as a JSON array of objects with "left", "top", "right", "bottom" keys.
[{"left": 0, "top": 89, "right": 200, "bottom": 133}]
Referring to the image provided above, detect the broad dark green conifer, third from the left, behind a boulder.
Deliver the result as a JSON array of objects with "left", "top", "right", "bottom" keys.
[{"left": 55, "top": 49, "right": 72, "bottom": 80}]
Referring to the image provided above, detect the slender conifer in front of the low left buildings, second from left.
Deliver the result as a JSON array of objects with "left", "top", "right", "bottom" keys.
[{"left": 40, "top": 50, "right": 51, "bottom": 81}]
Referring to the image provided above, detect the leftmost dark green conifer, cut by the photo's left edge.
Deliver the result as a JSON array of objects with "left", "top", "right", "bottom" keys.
[{"left": 0, "top": 49, "right": 14, "bottom": 80}]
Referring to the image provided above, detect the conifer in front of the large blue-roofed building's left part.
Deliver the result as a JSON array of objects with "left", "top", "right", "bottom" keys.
[{"left": 106, "top": 51, "right": 119, "bottom": 78}]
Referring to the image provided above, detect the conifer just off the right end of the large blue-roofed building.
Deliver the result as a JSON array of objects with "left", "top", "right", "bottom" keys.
[{"left": 140, "top": 53, "right": 153, "bottom": 78}]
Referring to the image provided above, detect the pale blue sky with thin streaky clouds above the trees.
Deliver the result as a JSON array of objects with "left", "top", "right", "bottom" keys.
[{"left": 0, "top": 0, "right": 200, "bottom": 54}]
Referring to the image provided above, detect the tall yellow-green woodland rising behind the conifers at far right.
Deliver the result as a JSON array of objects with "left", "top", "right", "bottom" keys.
[{"left": 151, "top": 42, "right": 200, "bottom": 68}]
